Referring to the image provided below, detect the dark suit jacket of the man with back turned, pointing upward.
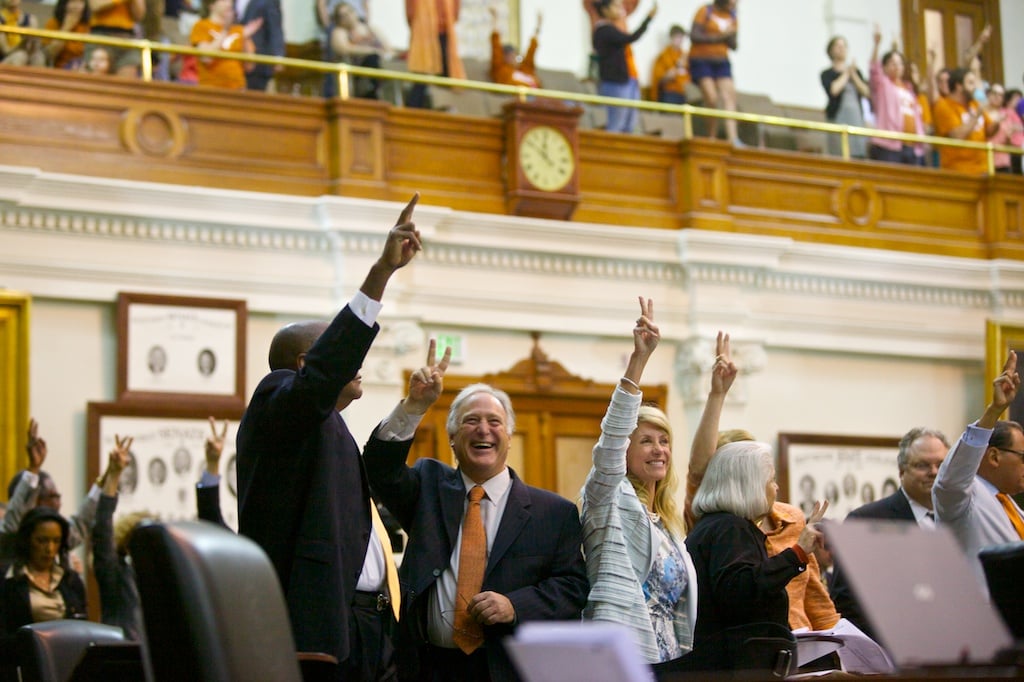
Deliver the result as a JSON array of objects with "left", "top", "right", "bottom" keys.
[{"left": 238, "top": 306, "right": 412, "bottom": 662}]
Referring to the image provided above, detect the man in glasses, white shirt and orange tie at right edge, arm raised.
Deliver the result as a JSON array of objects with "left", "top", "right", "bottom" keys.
[{"left": 932, "top": 350, "right": 1024, "bottom": 589}]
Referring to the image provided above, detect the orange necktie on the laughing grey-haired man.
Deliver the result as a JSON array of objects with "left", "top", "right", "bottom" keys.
[{"left": 452, "top": 485, "right": 487, "bottom": 653}]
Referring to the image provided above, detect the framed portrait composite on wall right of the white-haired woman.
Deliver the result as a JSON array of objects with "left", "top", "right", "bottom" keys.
[{"left": 776, "top": 433, "right": 899, "bottom": 520}]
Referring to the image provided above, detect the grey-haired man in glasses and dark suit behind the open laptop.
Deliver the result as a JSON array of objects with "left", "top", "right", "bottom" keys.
[{"left": 829, "top": 427, "right": 949, "bottom": 637}]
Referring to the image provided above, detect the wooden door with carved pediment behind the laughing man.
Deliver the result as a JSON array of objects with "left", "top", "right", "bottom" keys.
[{"left": 406, "top": 336, "right": 668, "bottom": 501}]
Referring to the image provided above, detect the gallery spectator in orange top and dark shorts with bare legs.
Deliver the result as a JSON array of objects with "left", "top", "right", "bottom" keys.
[{"left": 690, "top": 0, "right": 740, "bottom": 145}]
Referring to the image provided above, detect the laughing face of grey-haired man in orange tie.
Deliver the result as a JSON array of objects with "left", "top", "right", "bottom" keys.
[{"left": 452, "top": 393, "right": 512, "bottom": 483}]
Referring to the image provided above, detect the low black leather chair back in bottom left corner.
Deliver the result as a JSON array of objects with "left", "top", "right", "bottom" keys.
[{"left": 14, "top": 621, "right": 142, "bottom": 682}]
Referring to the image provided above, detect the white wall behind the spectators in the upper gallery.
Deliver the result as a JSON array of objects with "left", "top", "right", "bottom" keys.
[{"left": 358, "top": 0, "right": 1024, "bottom": 108}]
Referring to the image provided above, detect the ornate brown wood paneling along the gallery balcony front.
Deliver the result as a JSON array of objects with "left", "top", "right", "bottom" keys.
[{"left": 0, "top": 68, "right": 1024, "bottom": 259}]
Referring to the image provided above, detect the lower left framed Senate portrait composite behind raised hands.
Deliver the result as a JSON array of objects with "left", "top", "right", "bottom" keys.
[{"left": 86, "top": 402, "right": 242, "bottom": 528}]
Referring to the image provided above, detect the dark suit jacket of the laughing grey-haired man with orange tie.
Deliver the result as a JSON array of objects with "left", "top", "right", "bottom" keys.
[{"left": 366, "top": 445, "right": 590, "bottom": 680}]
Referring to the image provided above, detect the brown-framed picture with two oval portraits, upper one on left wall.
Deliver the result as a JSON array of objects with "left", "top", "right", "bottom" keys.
[{"left": 118, "top": 292, "right": 247, "bottom": 408}]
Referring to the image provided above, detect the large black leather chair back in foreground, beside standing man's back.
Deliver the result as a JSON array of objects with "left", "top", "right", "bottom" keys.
[{"left": 129, "top": 521, "right": 301, "bottom": 682}]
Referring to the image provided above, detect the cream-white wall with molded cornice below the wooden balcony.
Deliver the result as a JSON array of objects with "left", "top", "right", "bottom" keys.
[{"left": 6, "top": 168, "right": 1024, "bottom": 520}]
